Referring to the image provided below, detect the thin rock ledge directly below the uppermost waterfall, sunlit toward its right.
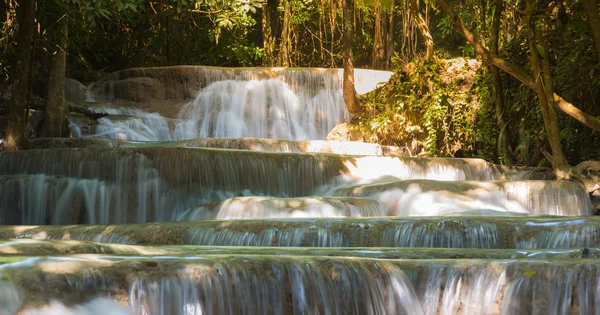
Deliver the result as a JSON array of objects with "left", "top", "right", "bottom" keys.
[{"left": 30, "top": 138, "right": 409, "bottom": 156}]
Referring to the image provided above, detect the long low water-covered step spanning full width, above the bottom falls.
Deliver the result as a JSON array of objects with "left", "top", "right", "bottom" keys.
[{"left": 0, "top": 216, "right": 600, "bottom": 249}]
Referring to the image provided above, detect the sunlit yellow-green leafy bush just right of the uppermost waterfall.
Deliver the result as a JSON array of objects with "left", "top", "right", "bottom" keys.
[{"left": 355, "top": 58, "right": 480, "bottom": 156}]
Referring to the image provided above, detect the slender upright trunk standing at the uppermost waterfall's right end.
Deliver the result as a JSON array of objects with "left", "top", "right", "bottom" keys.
[{"left": 342, "top": 0, "right": 361, "bottom": 115}]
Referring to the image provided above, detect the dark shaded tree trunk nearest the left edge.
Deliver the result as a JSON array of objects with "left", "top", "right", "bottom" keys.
[{"left": 4, "top": 0, "right": 35, "bottom": 150}]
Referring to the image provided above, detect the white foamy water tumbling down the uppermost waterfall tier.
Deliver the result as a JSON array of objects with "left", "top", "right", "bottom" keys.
[{"left": 79, "top": 69, "right": 350, "bottom": 141}]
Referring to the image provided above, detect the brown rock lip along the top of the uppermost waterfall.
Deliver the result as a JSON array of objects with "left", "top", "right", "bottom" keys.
[{"left": 92, "top": 66, "right": 392, "bottom": 103}]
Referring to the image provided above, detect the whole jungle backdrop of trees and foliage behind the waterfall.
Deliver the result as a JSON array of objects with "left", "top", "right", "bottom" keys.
[{"left": 0, "top": 0, "right": 600, "bottom": 178}]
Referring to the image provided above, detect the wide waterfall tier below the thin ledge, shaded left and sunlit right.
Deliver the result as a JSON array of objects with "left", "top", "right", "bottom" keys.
[{"left": 0, "top": 145, "right": 524, "bottom": 224}]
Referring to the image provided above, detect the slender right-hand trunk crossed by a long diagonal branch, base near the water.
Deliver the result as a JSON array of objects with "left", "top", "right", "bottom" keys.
[{"left": 527, "top": 0, "right": 572, "bottom": 179}]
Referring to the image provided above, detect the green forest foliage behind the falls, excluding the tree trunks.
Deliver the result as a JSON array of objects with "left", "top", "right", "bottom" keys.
[{"left": 0, "top": 0, "right": 600, "bottom": 170}]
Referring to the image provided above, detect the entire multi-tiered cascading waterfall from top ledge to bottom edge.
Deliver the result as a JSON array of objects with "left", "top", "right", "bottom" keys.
[{"left": 0, "top": 66, "right": 600, "bottom": 315}]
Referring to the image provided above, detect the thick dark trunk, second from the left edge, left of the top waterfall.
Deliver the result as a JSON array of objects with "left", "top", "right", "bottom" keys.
[{"left": 42, "top": 14, "right": 69, "bottom": 137}]
